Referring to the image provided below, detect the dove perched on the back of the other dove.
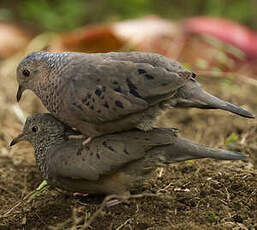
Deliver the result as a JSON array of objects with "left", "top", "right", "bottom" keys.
[{"left": 17, "top": 52, "right": 254, "bottom": 137}]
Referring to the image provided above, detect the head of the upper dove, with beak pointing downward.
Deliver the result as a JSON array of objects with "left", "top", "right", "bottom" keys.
[{"left": 16, "top": 51, "right": 68, "bottom": 101}]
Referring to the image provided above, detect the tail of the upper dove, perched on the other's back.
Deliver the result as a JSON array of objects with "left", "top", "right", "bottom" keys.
[{"left": 166, "top": 82, "right": 255, "bottom": 118}]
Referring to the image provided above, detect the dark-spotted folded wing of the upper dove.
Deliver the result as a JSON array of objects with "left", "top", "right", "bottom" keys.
[{"left": 61, "top": 55, "right": 186, "bottom": 123}]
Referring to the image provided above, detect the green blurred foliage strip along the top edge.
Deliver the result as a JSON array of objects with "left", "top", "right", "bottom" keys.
[{"left": 0, "top": 0, "right": 257, "bottom": 31}]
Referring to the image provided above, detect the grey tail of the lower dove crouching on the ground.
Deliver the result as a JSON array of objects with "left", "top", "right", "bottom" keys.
[{"left": 151, "top": 137, "right": 248, "bottom": 163}]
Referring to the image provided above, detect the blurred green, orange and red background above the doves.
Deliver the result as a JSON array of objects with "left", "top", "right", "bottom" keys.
[{"left": 0, "top": 0, "right": 257, "bottom": 77}]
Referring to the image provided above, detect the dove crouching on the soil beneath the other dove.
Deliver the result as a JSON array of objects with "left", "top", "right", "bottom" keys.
[{"left": 10, "top": 114, "right": 247, "bottom": 195}]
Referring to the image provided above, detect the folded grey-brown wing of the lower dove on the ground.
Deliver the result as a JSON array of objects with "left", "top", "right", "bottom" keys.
[{"left": 49, "top": 129, "right": 175, "bottom": 180}]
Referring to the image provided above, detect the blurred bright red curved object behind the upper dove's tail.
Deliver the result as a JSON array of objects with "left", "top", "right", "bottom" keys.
[{"left": 184, "top": 17, "right": 257, "bottom": 59}]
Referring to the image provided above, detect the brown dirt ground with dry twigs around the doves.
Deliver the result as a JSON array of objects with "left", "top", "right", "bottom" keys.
[{"left": 0, "top": 60, "right": 257, "bottom": 230}]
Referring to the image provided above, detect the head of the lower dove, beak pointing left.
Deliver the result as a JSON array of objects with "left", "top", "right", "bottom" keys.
[{"left": 10, "top": 113, "right": 67, "bottom": 149}]
